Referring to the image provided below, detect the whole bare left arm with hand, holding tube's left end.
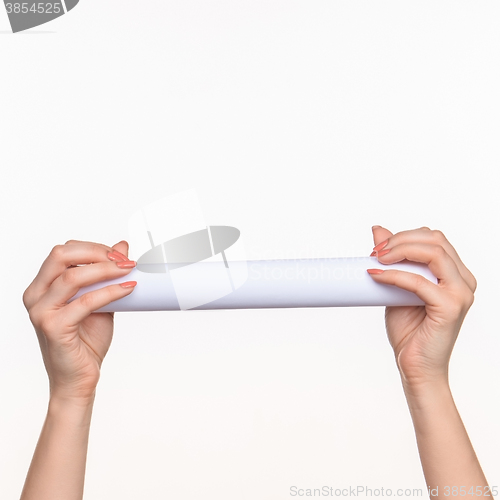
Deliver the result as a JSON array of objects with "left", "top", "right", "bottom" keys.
[{"left": 21, "top": 241, "right": 135, "bottom": 500}]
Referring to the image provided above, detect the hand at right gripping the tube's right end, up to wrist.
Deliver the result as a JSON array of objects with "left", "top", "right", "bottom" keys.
[{"left": 369, "top": 226, "right": 476, "bottom": 387}]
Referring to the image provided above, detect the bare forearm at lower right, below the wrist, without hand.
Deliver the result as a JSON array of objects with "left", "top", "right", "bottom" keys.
[{"left": 403, "top": 380, "right": 492, "bottom": 499}]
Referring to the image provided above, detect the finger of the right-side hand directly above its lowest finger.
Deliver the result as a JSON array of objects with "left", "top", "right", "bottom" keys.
[{"left": 377, "top": 243, "right": 463, "bottom": 287}]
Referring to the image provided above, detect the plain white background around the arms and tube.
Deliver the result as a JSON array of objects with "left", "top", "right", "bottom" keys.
[{"left": 0, "top": 0, "right": 500, "bottom": 500}]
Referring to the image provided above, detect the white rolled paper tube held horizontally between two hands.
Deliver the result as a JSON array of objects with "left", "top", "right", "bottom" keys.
[{"left": 70, "top": 257, "right": 437, "bottom": 312}]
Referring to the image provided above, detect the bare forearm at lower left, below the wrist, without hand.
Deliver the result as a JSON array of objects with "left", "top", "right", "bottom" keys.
[{"left": 21, "top": 399, "right": 93, "bottom": 500}]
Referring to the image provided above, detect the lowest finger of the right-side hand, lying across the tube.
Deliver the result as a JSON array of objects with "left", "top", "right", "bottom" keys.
[{"left": 370, "top": 269, "right": 446, "bottom": 306}]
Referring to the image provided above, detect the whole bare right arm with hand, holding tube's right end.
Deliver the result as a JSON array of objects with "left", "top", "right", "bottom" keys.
[{"left": 369, "top": 226, "right": 492, "bottom": 500}]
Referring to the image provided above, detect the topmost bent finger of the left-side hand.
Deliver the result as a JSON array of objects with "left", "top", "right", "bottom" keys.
[{"left": 24, "top": 242, "right": 119, "bottom": 308}]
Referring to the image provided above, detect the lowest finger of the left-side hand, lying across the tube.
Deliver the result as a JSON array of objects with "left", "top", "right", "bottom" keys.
[{"left": 63, "top": 281, "right": 137, "bottom": 326}]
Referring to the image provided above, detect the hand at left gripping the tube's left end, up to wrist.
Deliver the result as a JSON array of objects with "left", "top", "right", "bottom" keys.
[{"left": 23, "top": 240, "right": 137, "bottom": 401}]
